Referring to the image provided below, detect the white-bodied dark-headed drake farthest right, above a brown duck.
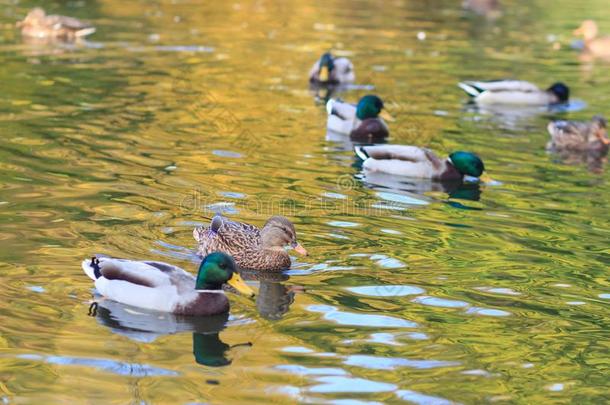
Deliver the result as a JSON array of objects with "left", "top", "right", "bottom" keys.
[{"left": 458, "top": 80, "right": 570, "bottom": 106}]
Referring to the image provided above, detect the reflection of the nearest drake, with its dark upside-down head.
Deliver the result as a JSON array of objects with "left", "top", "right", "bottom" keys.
[{"left": 90, "top": 299, "right": 252, "bottom": 367}]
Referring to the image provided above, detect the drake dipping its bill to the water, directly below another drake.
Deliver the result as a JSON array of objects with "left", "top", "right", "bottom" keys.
[{"left": 355, "top": 145, "right": 485, "bottom": 181}]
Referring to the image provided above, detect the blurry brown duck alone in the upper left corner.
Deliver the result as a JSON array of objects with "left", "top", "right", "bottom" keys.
[{"left": 17, "top": 7, "right": 95, "bottom": 41}]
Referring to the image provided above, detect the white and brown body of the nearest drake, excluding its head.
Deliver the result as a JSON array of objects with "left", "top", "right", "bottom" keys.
[{"left": 82, "top": 257, "right": 228, "bottom": 315}]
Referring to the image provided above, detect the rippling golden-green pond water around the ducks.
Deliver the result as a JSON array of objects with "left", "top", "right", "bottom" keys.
[{"left": 0, "top": 0, "right": 610, "bottom": 404}]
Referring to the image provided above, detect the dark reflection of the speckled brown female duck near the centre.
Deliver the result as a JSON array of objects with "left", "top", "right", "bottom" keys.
[{"left": 241, "top": 272, "right": 304, "bottom": 321}]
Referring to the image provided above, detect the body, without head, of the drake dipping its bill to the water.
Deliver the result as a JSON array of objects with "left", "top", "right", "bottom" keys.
[{"left": 355, "top": 145, "right": 454, "bottom": 179}]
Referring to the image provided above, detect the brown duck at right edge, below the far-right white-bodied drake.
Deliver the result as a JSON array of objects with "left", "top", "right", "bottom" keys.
[{"left": 546, "top": 115, "right": 610, "bottom": 151}]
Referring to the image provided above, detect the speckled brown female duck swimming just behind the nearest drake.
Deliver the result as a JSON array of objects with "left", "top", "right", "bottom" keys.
[{"left": 193, "top": 215, "right": 307, "bottom": 271}]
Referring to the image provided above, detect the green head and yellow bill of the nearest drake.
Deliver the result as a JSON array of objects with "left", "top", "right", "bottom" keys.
[{"left": 195, "top": 252, "right": 254, "bottom": 297}]
